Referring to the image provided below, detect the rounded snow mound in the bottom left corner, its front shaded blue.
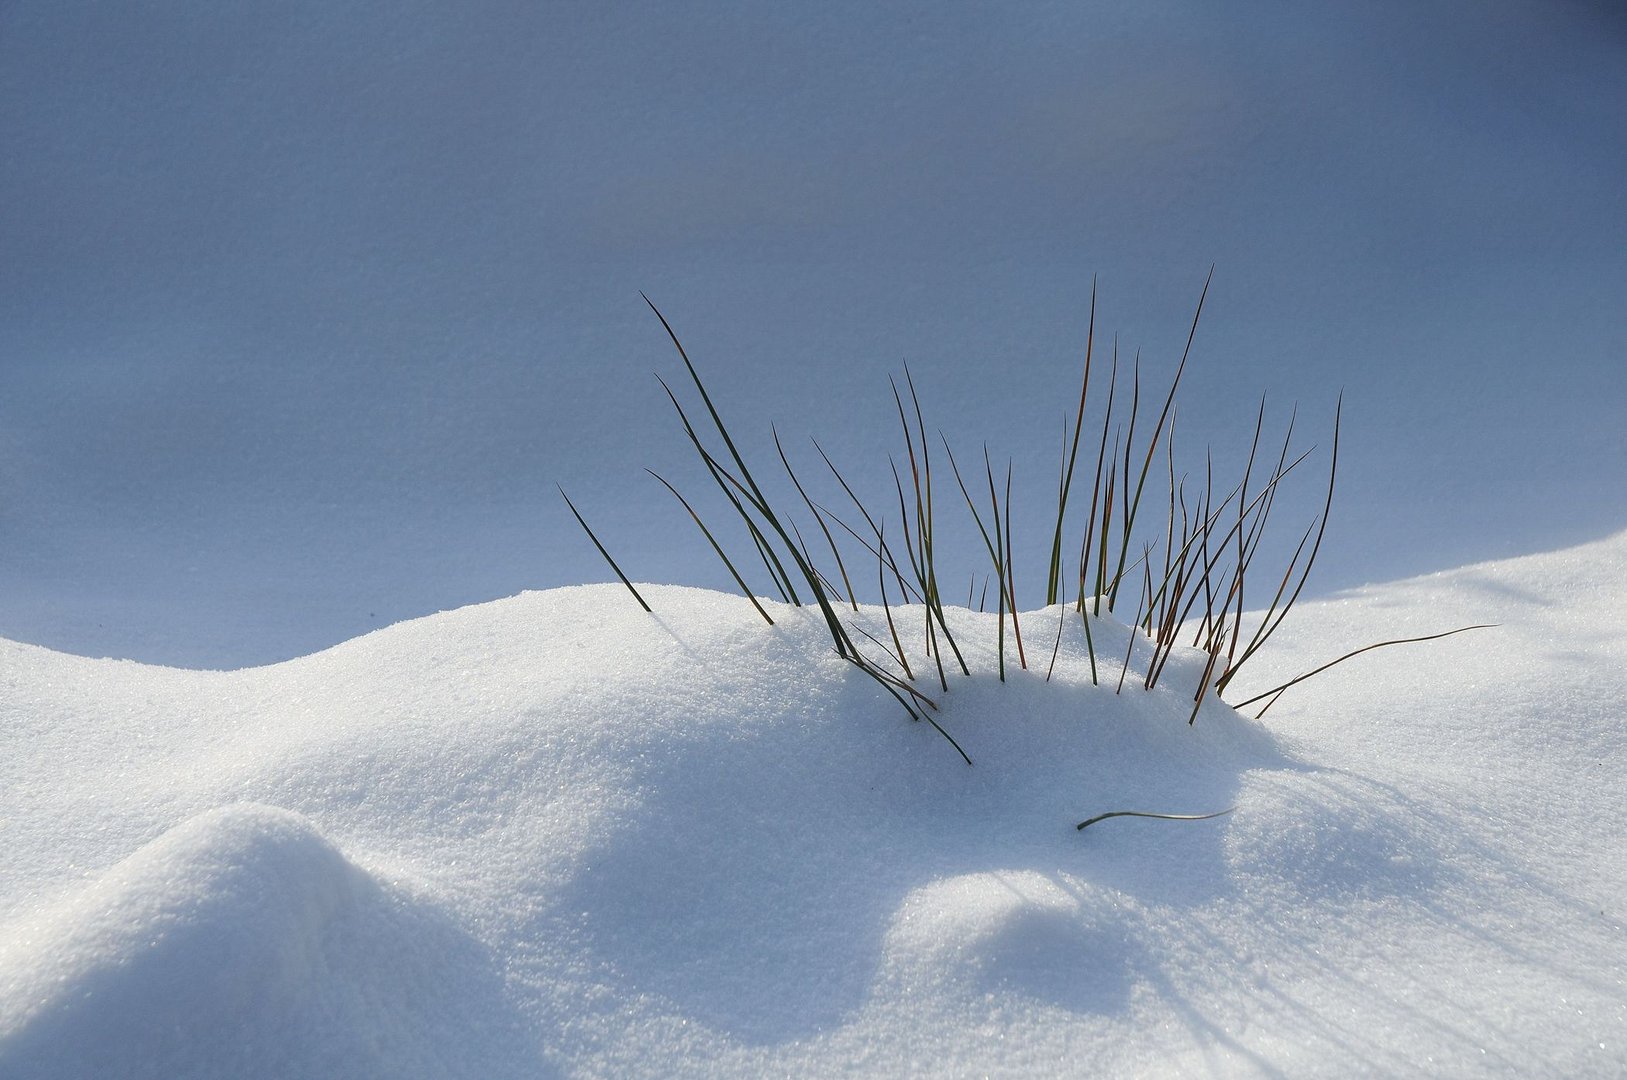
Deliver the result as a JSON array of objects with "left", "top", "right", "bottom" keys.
[{"left": 0, "top": 803, "right": 533, "bottom": 1077}]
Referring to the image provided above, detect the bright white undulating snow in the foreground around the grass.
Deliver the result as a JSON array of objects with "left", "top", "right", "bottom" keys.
[{"left": 0, "top": 533, "right": 1627, "bottom": 1078}]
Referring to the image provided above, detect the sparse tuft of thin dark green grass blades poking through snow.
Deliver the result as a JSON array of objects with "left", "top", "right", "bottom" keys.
[{"left": 560, "top": 276, "right": 1481, "bottom": 767}]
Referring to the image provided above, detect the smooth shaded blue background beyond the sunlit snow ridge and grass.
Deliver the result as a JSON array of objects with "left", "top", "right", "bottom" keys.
[{"left": 0, "top": 2, "right": 1627, "bottom": 665}]
